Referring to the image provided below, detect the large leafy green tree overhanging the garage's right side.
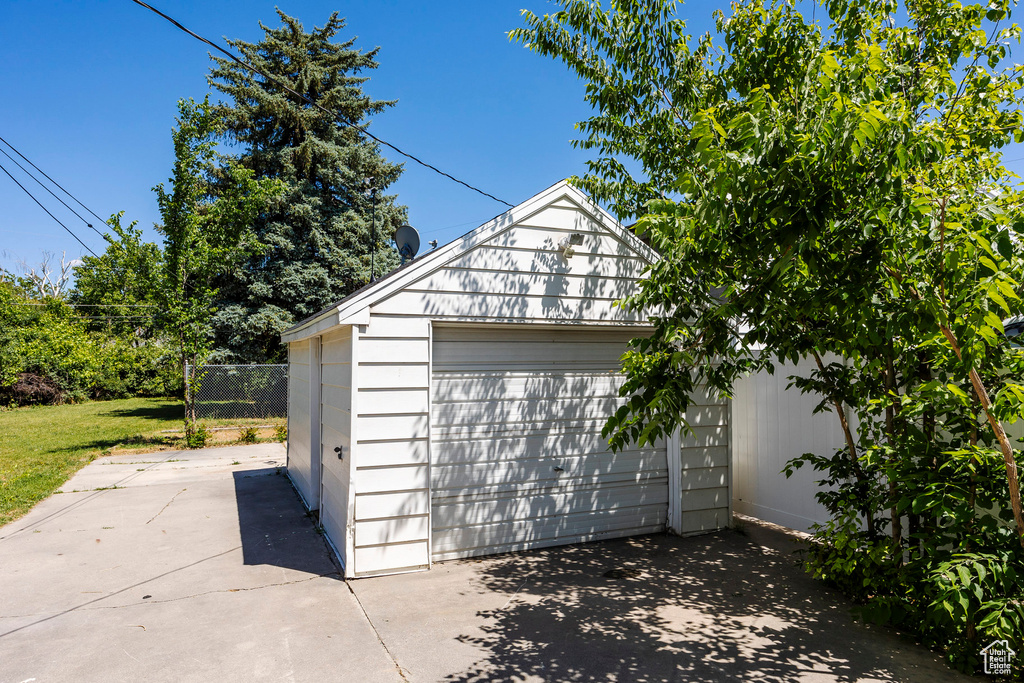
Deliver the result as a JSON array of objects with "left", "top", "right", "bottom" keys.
[{"left": 512, "top": 0, "right": 1024, "bottom": 668}]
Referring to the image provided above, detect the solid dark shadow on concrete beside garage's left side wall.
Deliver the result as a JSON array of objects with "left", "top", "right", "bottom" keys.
[{"left": 232, "top": 467, "right": 340, "bottom": 579}]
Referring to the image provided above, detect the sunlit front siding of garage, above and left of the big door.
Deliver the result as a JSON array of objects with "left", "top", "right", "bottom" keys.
[{"left": 346, "top": 199, "right": 646, "bottom": 575}]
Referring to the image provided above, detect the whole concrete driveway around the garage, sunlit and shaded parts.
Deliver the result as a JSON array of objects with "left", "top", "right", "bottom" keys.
[{"left": 0, "top": 444, "right": 972, "bottom": 683}]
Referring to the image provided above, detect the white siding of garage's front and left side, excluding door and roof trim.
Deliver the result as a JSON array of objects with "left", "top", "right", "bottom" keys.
[{"left": 289, "top": 195, "right": 729, "bottom": 577}]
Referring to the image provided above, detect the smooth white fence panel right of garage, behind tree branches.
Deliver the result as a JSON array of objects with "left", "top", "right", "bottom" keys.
[{"left": 732, "top": 359, "right": 845, "bottom": 531}]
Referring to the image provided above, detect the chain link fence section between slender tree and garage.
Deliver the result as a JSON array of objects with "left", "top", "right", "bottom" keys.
[{"left": 185, "top": 365, "right": 288, "bottom": 420}]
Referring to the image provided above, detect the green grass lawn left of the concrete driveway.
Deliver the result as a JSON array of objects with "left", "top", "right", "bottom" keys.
[{"left": 0, "top": 398, "right": 286, "bottom": 525}]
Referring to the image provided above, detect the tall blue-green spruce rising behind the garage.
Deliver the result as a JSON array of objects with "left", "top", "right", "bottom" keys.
[{"left": 210, "top": 10, "right": 406, "bottom": 362}]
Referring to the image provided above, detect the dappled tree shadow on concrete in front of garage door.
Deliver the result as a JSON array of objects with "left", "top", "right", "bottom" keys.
[{"left": 447, "top": 528, "right": 971, "bottom": 683}]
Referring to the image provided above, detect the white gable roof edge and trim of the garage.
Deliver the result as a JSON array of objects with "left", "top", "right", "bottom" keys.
[{"left": 281, "top": 180, "right": 658, "bottom": 344}]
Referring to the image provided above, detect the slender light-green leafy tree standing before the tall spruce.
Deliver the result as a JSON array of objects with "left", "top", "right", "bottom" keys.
[{"left": 154, "top": 98, "right": 282, "bottom": 436}]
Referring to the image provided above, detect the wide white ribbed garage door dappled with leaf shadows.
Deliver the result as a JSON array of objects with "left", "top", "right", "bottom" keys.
[{"left": 430, "top": 327, "right": 669, "bottom": 560}]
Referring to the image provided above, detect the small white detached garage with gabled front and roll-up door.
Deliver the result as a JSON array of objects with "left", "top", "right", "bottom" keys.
[{"left": 283, "top": 182, "right": 731, "bottom": 577}]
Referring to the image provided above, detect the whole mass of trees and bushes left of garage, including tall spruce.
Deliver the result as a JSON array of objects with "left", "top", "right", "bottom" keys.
[{"left": 0, "top": 10, "right": 407, "bottom": 404}]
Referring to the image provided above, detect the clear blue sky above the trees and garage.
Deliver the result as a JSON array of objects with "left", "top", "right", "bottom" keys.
[{"left": 0, "top": 0, "right": 1024, "bottom": 278}]
